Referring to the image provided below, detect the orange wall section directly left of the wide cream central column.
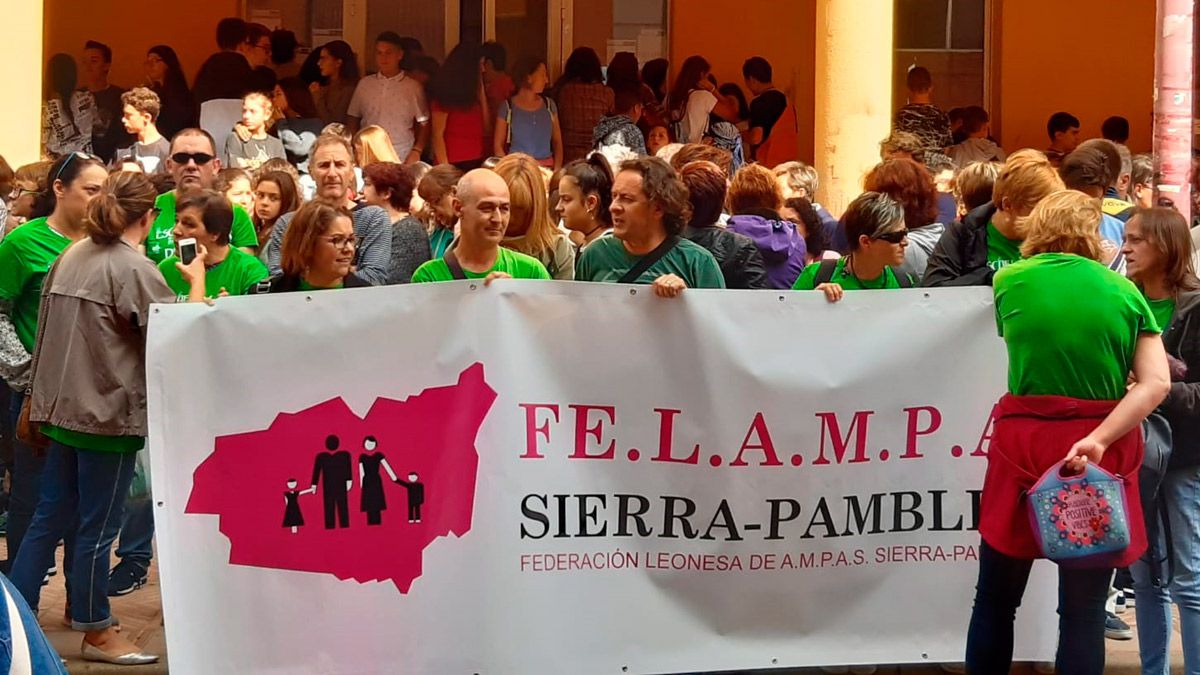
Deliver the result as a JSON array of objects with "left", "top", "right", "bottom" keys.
[{"left": 671, "top": 0, "right": 816, "bottom": 162}]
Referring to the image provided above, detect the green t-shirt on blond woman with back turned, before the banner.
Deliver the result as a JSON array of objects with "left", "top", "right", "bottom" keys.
[{"left": 992, "top": 253, "right": 1160, "bottom": 401}]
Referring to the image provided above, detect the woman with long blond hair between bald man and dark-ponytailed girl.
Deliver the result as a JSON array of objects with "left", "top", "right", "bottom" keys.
[{"left": 494, "top": 155, "right": 575, "bottom": 281}]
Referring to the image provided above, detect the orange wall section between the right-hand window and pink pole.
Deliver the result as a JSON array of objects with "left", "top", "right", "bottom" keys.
[{"left": 1000, "top": 0, "right": 1157, "bottom": 153}]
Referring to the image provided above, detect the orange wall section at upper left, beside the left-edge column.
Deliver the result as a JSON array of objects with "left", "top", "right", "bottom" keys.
[{"left": 42, "top": 0, "right": 241, "bottom": 88}]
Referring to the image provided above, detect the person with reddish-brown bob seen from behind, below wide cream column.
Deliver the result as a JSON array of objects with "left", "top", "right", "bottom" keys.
[{"left": 863, "top": 160, "right": 946, "bottom": 279}]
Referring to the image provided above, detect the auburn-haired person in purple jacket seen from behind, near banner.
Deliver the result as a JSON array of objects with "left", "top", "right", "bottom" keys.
[{"left": 726, "top": 165, "right": 804, "bottom": 288}]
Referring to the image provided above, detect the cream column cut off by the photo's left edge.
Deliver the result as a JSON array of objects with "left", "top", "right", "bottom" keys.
[{"left": 0, "top": 0, "right": 46, "bottom": 164}]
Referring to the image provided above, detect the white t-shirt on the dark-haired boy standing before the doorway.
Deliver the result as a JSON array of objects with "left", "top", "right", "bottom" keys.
[{"left": 346, "top": 71, "right": 430, "bottom": 156}]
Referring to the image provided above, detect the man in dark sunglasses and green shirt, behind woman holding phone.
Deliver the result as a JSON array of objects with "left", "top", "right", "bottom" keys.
[{"left": 145, "top": 129, "right": 258, "bottom": 263}]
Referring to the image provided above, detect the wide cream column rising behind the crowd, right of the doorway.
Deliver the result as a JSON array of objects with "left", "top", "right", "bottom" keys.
[{"left": 814, "top": 0, "right": 893, "bottom": 214}]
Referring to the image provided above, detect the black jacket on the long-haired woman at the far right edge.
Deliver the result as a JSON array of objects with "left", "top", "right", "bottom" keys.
[{"left": 1159, "top": 291, "right": 1200, "bottom": 468}]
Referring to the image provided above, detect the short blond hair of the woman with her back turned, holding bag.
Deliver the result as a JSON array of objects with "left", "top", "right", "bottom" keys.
[{"left": 1021, "top": 190, "right": 1104, "bottom": 261}]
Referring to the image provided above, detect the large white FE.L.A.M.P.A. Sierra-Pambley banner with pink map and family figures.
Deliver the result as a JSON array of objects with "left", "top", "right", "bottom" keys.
[{"left": 149, "top": 281, "right": 1056, "bottom": 675}]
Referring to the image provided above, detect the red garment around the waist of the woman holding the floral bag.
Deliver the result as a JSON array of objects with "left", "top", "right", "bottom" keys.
[{"left": 979, "top": 394, "right": 1146, "bottom": 567}]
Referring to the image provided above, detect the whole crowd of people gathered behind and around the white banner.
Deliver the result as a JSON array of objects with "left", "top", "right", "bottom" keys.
[{"left": 0, "top": 11, "right": 1200, "bottom": 674}]
